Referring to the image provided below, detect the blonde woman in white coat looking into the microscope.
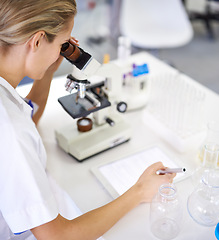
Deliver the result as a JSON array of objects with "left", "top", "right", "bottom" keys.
[{"left": 0, "top": 0, "right": 175, "bottom": 240}]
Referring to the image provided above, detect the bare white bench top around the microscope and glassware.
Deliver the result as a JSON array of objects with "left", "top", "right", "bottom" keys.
[{"left": 18, "top": 53, "right": 219, "bottom": 240}]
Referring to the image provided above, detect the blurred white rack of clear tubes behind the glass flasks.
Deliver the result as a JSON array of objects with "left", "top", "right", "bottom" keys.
[{"left": 143, "top": 69, "right": 206, "bottom": 152}]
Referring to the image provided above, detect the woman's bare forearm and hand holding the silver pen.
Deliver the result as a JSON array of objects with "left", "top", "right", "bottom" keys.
[{"left": 31, "top": 162, "right": 175, "bottom": 240}]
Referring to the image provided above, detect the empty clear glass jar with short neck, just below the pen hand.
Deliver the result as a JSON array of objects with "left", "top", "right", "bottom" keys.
[{"left": 150, "top": 184, "right": 182, "bottom": 240}]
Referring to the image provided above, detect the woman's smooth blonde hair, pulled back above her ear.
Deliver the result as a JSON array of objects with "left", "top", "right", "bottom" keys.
[{"left": 0, "top": 0, "right": 77, "bottom": 47}]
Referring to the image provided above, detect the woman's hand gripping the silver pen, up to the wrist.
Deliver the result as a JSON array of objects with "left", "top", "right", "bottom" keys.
[{"left": 133, "top": 162, "right": 176, "bottom": 202}]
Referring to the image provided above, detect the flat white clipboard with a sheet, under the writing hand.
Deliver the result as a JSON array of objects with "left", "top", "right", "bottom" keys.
[{"left": 91, "top": 146, "right": 189, "bottom": 199}]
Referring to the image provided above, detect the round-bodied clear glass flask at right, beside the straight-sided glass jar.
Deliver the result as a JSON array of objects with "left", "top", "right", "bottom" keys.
[{"left": 187, "top": 169, "right": 219, "bottom": 227}]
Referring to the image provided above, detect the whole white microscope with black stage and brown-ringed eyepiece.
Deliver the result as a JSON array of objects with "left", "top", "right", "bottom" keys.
[{"left": 55, "top": 42, "right": 131, "bottom": 162}]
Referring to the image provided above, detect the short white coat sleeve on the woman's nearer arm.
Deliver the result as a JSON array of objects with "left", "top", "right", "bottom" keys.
[{"left": 0, "top": 121, "right": 58, "bottom": 233}]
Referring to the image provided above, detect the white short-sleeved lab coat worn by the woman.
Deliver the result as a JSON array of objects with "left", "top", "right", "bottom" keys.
[{"left": 0, "top": 77, "right": 80, "bottom": 240}]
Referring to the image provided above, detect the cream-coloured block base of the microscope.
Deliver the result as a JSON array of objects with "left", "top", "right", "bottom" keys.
[{"left": 55, "top": 116, "right": 131, "bottom": 162}]
